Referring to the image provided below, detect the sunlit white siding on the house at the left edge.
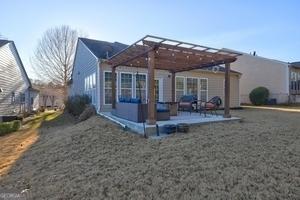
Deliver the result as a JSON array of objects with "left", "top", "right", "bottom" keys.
[{"left": 0, "top": 42, "right": 30, "bottom": 116}]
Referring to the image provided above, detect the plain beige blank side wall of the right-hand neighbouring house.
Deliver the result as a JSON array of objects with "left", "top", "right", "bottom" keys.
[{"left": 231, "top": 54, "right": 289, "bottom": 103}]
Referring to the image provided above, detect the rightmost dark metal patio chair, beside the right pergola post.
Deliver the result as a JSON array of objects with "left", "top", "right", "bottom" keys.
[{"left": 198, "top": 96, "right": 222, "bottom": 117}]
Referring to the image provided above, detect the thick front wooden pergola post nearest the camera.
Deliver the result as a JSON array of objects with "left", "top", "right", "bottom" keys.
[{"left": 147, "top": 51, "right": 156, "bottom": 125}]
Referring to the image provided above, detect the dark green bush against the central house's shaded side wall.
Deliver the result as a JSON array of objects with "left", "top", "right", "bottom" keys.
[{"left": 66, "top": 95, "right": 91, "bottom": 116}]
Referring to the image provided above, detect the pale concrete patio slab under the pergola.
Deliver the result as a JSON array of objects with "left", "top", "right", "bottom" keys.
[{"left": 99, "top": 112, "right": 240, "bottom": 136}]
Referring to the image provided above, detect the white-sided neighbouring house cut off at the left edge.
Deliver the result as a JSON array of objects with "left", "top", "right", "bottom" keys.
[{"left": 0, "top": 40, "right": 38, "bottom": 121}]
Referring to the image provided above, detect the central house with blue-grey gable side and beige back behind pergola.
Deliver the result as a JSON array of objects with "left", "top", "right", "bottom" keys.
[{"left": 69, "top": 38, "right": 241, "bottom": 111}]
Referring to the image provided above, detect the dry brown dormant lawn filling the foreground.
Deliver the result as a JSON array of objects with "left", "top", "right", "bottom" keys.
[{"left": 0, "top": 108, "right": 300, "bottom": 199}]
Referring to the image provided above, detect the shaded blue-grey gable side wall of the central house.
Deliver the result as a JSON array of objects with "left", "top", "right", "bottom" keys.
[{"left": 69, "top": 40, "right": 100, "bottom": 109}]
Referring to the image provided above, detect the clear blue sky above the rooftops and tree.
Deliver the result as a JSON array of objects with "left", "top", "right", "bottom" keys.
[{"left": 0, "top": 0, "right": 300, "bottom": 78}]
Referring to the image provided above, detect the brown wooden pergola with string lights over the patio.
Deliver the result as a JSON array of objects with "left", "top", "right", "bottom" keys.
[{"left": 106, "top": 35, "right": 240, "bottom": 124}]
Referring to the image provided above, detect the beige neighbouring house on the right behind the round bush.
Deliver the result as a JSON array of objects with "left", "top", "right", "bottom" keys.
[{"left": 231, "top": 50, "right": 300, "bottom": 104}]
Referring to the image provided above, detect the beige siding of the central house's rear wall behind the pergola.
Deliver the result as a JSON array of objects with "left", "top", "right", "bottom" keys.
[{"left": 99, "top": 64, "right": 240, "bottom": 111}]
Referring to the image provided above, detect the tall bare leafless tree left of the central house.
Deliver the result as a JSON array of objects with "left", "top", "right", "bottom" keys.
[{"left": 32, "top": 25, "right": 79, "bottom": 98}]
